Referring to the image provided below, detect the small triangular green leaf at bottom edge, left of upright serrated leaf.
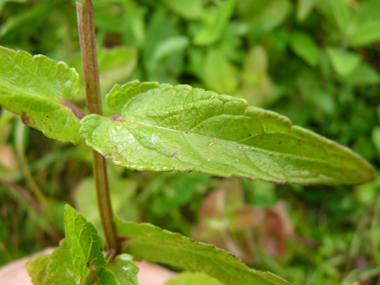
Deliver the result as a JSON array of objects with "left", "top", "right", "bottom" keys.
[{"left": 43, "top": 240, "right": 81, "bottom": 285}]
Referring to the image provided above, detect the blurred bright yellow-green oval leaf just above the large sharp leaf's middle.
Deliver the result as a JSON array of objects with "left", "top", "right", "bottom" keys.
[{"left": 204, "top": 49, "right": 238, "bottom": 94}]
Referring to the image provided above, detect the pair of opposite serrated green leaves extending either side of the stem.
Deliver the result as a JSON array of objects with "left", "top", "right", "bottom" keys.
[{"left": 0, "top": 45, "right": 375, "bottom": 185}]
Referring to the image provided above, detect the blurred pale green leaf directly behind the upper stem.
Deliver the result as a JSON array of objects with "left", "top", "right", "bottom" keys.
[{"left": 68, "top": 47, "right": 137, "bottom": 95}]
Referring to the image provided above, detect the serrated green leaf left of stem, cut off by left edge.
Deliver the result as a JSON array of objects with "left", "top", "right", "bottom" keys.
[{"left": 0, "top": 47, "right": 83, "bottom": 143}]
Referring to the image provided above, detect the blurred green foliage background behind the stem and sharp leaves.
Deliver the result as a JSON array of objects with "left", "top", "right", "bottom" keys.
[{"left": 0, "top": 0, "right": 380, "bottom": 285}]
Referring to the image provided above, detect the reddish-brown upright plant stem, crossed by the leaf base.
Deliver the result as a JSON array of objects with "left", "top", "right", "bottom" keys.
[{"left": 77, "top": 0, "right": 121, "bottom": 254}]
